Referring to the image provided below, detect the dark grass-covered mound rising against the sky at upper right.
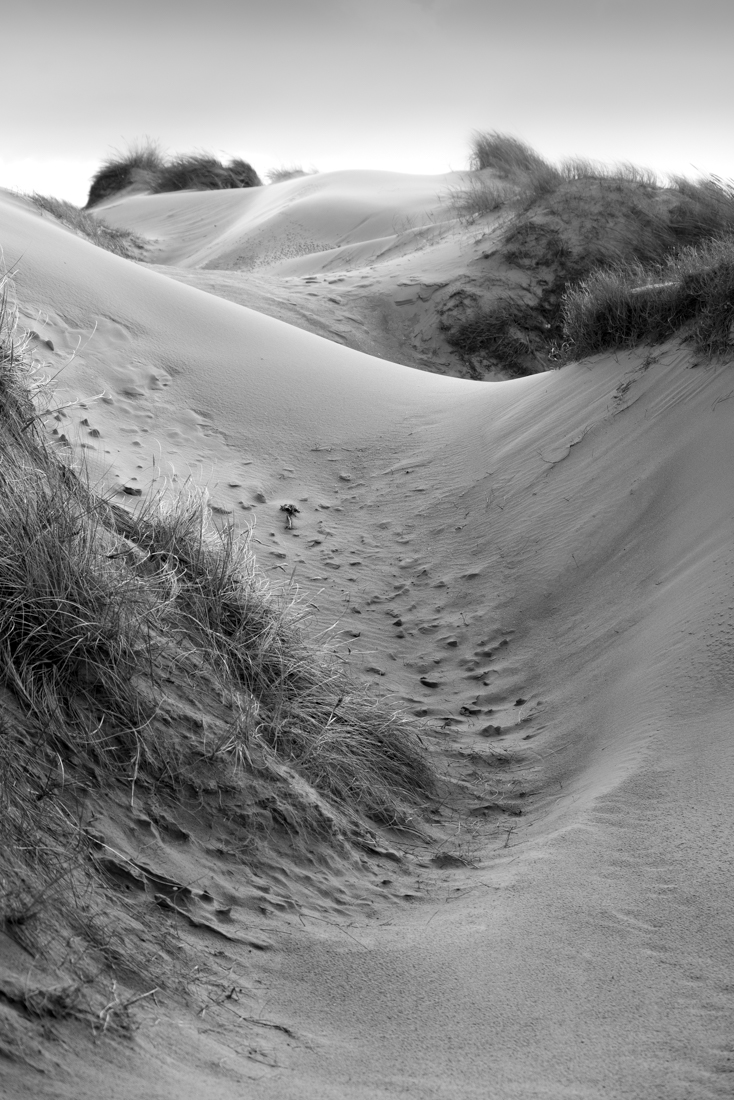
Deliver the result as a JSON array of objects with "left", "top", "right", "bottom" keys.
[{"left": 440, "top": 133, "right": 734, "bottom": 377}]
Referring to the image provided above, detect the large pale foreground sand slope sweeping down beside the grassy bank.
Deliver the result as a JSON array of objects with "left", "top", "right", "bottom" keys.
[{"left": 0, "top": 180, "right": 734, "bottom": 1100}]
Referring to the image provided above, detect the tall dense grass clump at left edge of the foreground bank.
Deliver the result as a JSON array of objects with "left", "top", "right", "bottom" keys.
[{"left": 0, "top": 453, "right": 159, "bottom": 760}]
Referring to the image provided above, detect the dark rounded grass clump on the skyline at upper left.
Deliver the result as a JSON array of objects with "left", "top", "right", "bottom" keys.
[{"left": 87, "top": 141, "right": 262, "bottom": 209}]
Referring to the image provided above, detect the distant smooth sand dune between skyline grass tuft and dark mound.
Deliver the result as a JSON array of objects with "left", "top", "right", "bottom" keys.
[{"left": 97, "top": 172, "right": 513, "bottom": 377}]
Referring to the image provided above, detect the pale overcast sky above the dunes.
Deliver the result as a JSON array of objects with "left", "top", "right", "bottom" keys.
[{"left": 0, "top": 0, "right": 734, "bottom": 204}]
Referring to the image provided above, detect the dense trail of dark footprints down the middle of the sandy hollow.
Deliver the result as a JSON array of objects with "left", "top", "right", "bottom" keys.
[{"left": 246, "top": 486, "right": 540, "bottom": 752}]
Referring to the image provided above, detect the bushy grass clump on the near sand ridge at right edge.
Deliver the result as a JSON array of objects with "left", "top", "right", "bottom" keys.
[{"left": 563, "top": 237, "right": 734, "bottom": 358}]
